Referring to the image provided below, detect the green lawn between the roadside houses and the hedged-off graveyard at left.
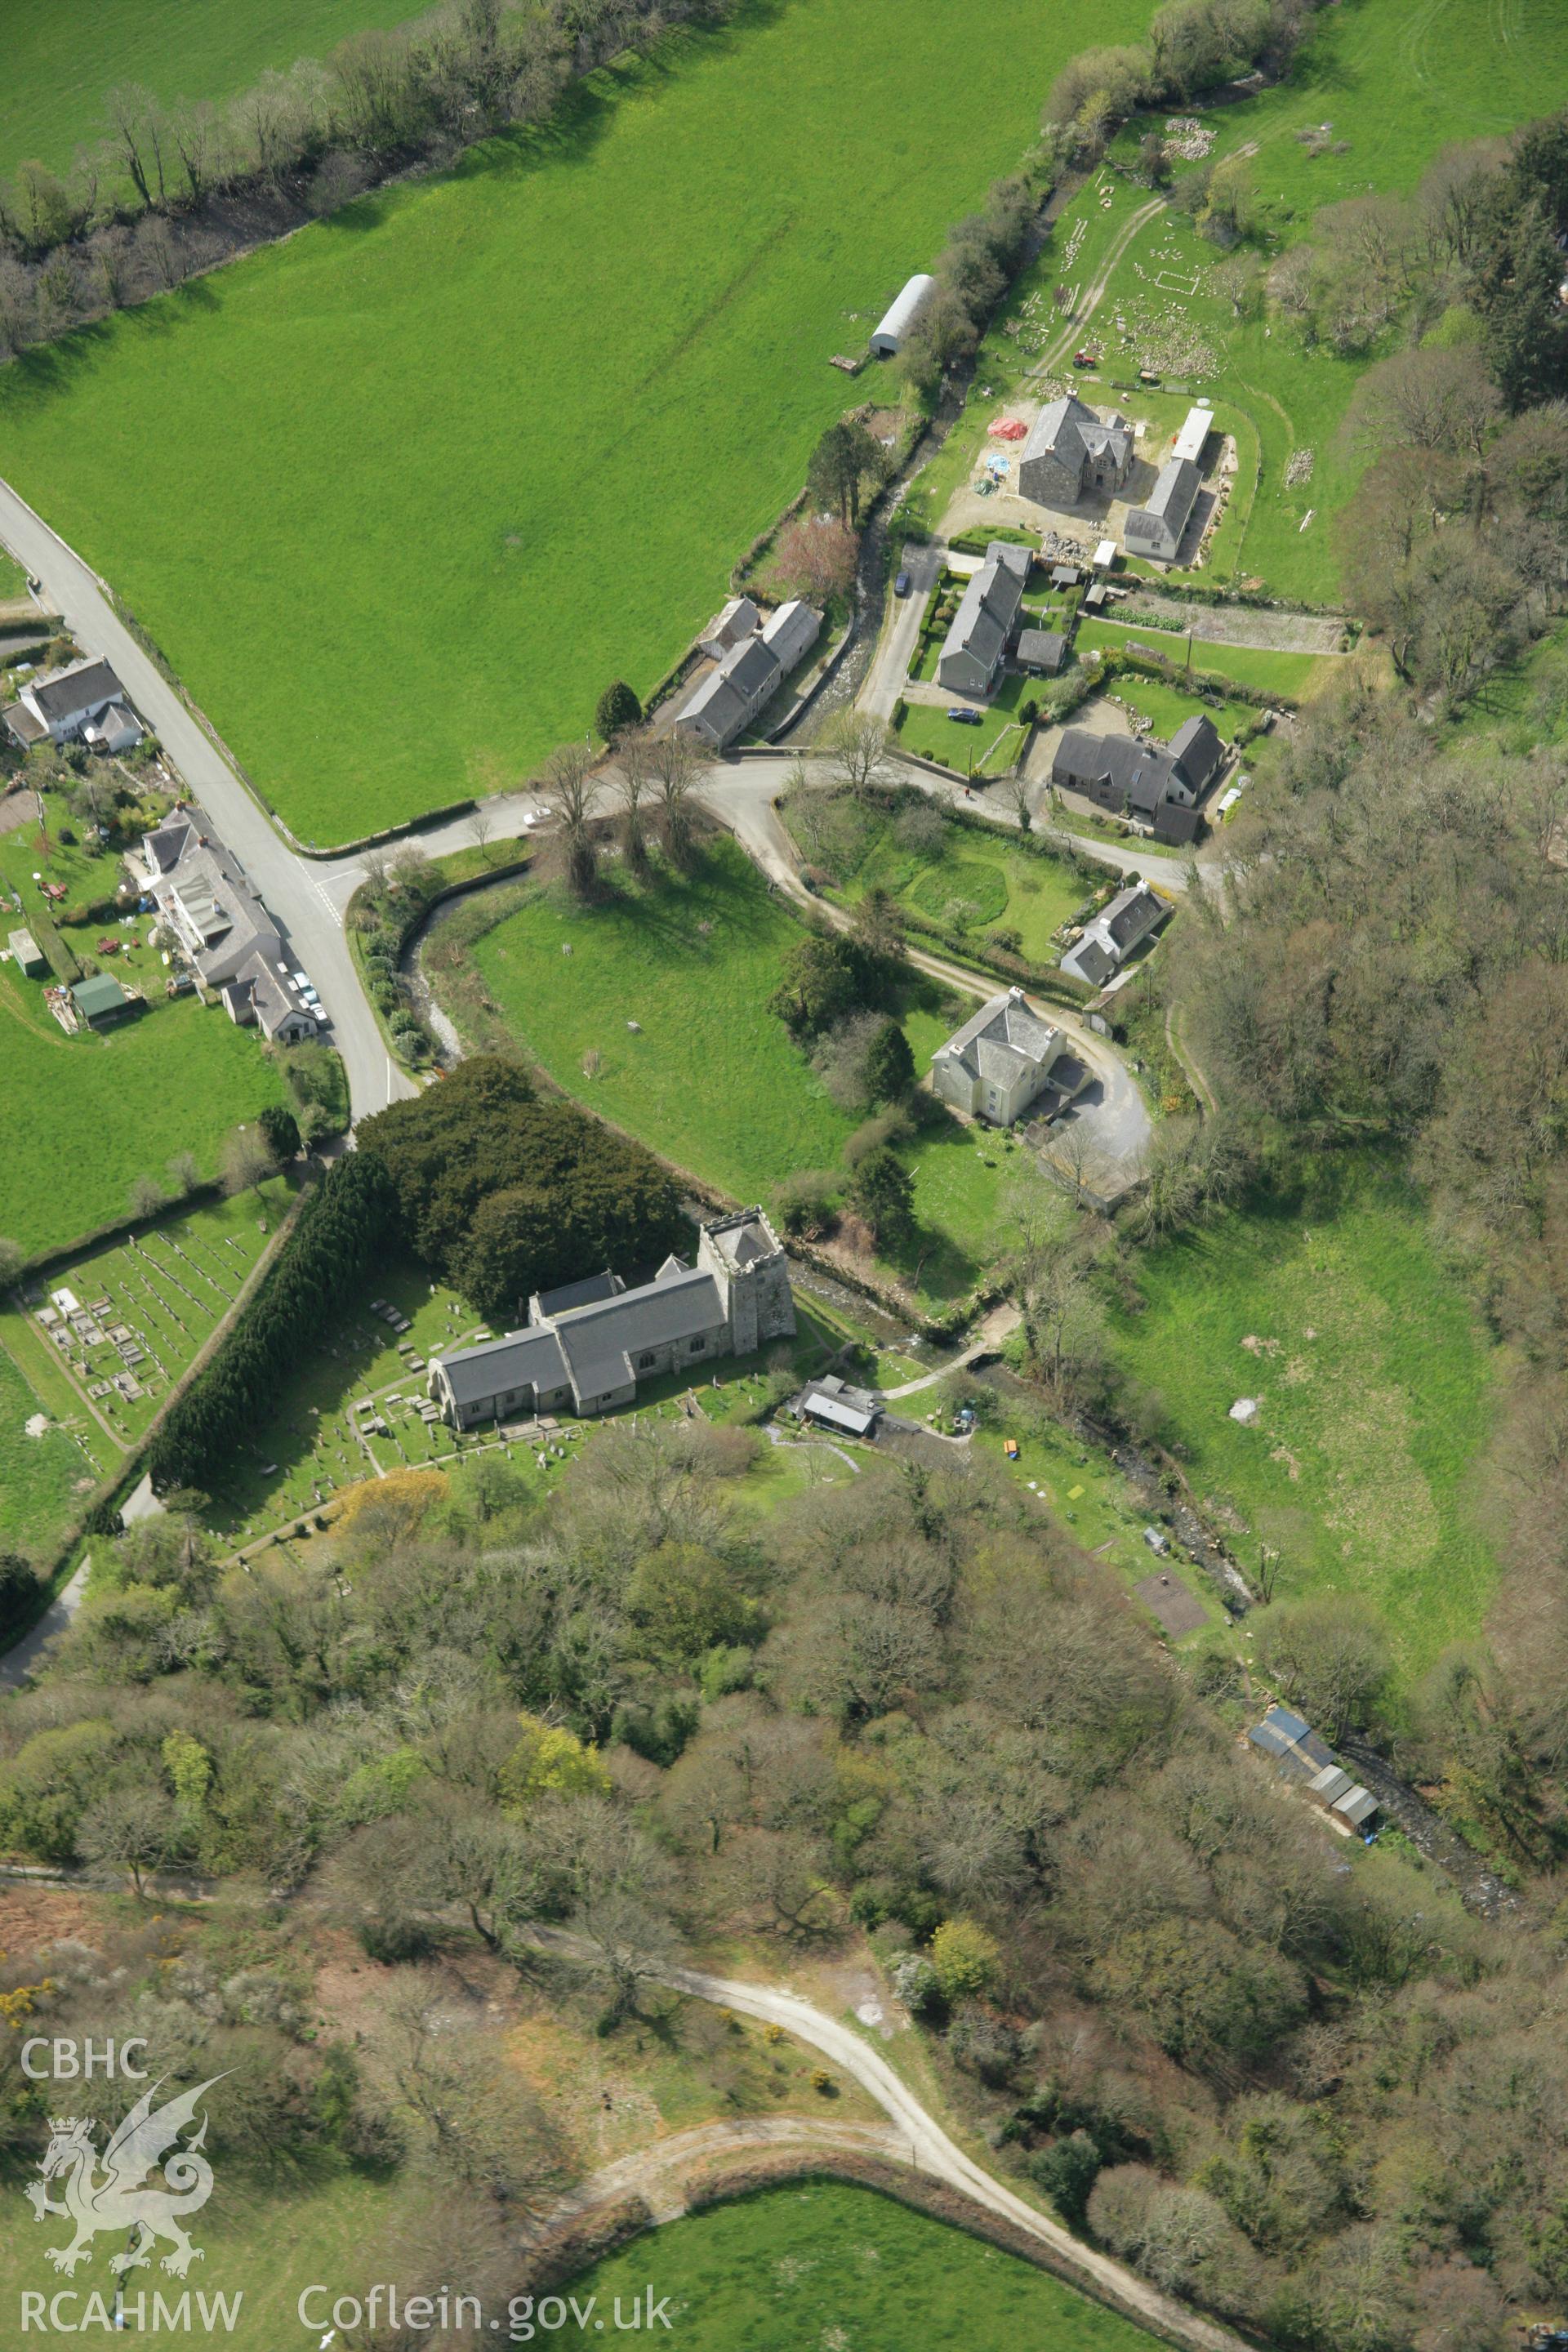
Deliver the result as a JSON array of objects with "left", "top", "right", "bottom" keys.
[{"left": 0, "top": 964, "right": 287, "bottom": 1251}]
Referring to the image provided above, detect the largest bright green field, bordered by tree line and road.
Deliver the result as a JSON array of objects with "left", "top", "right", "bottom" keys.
[{"left": 0, "top": 0, "right": 1145, "bottom": 842}]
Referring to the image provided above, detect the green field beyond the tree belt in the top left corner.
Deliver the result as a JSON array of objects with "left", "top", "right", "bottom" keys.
[{"left": 0, "top": 0, "right": 414, "bottom": 179}]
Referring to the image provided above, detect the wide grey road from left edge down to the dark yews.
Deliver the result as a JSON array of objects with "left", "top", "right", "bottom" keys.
[{"left": 0, "top": 482, "right": 416, "bottom": 1120}]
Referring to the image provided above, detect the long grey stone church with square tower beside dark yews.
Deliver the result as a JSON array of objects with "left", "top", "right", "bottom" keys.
[{"left": 430, "top": 1209, "right": 795, "bottom": 1430}]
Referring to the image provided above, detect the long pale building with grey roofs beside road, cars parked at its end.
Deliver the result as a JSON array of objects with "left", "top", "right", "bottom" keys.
[{"left": 125, "top": 804, "right": 319, "bottom": 1045}]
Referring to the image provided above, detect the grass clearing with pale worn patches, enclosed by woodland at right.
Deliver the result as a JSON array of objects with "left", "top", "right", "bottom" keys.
[{"left": 1114, "top": 1160, "right": 1495, "bottom": 1675}]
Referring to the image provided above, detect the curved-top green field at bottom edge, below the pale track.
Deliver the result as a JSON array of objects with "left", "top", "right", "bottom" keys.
[{"left": 566, "top": 2180, "right": 1152, "bottom": 2352}]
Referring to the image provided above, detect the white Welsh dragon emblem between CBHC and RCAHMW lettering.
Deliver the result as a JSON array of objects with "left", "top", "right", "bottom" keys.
[{"left": 29, "top": 2074, "right": 223, "bottom": 2279}]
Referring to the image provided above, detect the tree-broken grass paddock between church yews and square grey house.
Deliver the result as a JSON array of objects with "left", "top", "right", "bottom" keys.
[{"left": 439, "top": 840, "right": 1016, "bottom": 1298}]
